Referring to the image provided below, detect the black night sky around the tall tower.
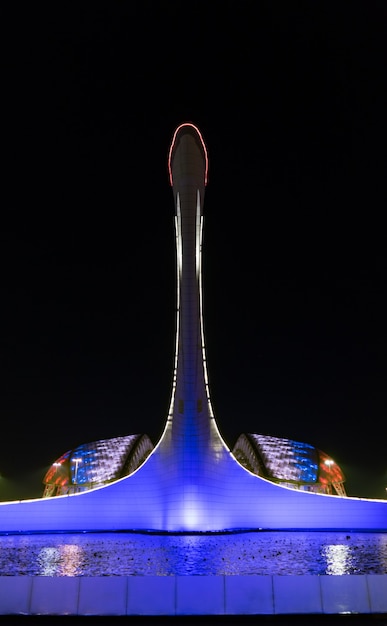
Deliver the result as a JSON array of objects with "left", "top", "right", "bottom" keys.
[{"left": 0, "top": 0, "right": 387, "bottom": 499}]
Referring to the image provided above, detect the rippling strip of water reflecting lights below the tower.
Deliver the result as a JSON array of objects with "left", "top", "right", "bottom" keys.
[{"left": 0, "top": 532, "right": 387, "bottom": 576}]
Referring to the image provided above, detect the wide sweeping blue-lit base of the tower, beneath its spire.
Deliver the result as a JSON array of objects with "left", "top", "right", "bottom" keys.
[{"left": 0, "top": 450, "right": 387, "bottom": 532}]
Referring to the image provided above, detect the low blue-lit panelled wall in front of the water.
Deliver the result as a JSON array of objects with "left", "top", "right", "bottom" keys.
[{"left": 0, "top": 574, "right": 387, "bottom": 615}]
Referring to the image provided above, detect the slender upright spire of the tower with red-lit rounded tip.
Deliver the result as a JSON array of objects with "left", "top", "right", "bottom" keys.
[{"left": 161, "top": 123, "right": 225, "bottom": 458}]
